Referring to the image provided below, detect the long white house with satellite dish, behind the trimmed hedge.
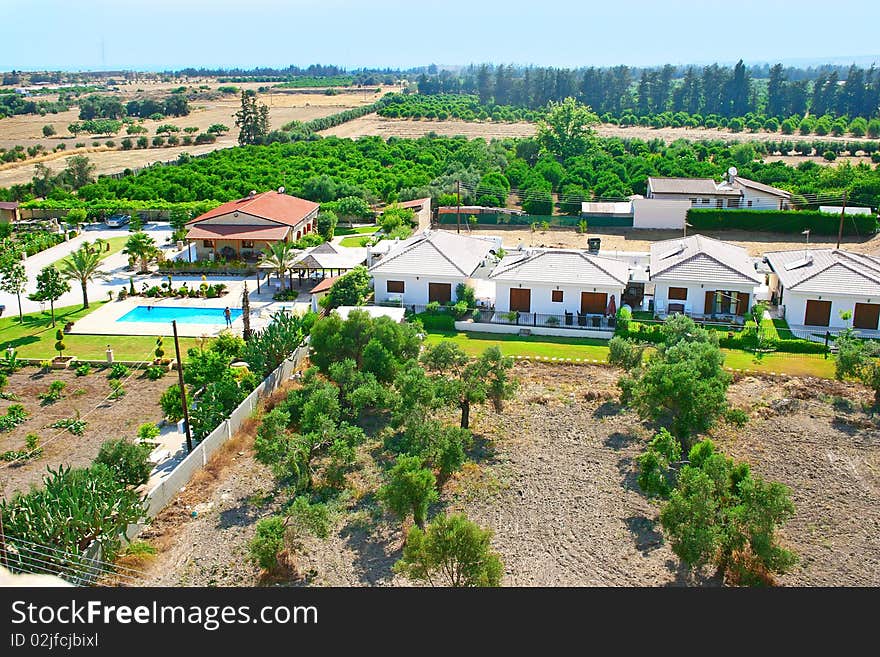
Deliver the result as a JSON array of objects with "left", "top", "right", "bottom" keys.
[{"left": 645, "top": 169, "right": 791, "bottom": 210}]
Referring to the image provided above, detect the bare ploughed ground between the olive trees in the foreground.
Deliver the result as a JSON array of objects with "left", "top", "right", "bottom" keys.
[{"left": 134, "top": 364, "right": 880, "bottom": 586}]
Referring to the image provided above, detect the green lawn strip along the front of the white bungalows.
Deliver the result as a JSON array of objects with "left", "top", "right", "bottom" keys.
[{"left": 426, "top": 330, "right": 834, "bottom": 379}]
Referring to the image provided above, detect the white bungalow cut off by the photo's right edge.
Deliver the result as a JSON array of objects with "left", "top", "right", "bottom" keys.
[{"left": 764, "top": 249, "right": 880, "bottom": 331}]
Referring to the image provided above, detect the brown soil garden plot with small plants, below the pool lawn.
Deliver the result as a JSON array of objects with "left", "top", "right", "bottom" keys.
[{"left": 0, "top": 367, "right": 172, "bottom": 497}]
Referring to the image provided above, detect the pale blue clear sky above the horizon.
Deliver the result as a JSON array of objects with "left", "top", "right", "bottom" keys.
[{"left": 0, "top": 0, "right": 880, "bottom": 70}]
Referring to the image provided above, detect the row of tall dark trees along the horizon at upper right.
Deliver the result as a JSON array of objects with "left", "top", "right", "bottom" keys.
[{"left": 417, "top": 60, "right": 880, "bottom": 120}]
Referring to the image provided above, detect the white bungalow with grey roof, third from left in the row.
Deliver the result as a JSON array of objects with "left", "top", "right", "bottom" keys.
[{"left": 648, "top": 235, "right": 764, "bottom": 318}]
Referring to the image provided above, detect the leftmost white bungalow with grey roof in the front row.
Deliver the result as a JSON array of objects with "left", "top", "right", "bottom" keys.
[{"left": 370, "top": 230, "right": 501, "bottom": 306}]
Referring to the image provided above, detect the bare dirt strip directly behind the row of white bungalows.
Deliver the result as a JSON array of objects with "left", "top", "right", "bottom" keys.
[{"left": 443, "top": 225, "right": 880, "bottom": 256}]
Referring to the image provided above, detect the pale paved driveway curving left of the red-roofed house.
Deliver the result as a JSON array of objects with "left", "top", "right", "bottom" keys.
[{"left": 0, "top": 224, "right": 171, "bottom": 317}]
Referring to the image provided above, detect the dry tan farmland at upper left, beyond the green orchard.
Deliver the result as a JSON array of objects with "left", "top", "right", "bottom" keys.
[{"left": 0, "top": 83, "right": 396, "bottom": 187}]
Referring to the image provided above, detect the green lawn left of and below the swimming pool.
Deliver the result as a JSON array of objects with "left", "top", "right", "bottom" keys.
[{"left": 0, "top": 301, "right": 198, "bottom": 360}]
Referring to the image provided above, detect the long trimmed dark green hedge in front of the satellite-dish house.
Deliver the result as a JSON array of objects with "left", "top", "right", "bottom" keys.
[{"left": 687, "top": 208, "right": 878, "bottom": 235}]
